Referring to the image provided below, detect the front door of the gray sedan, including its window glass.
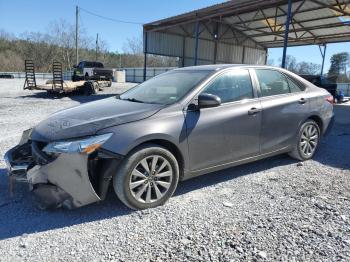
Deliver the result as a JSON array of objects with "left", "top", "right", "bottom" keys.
[{"left": 185, "top": 69, "right": 261, "bottom": 171}]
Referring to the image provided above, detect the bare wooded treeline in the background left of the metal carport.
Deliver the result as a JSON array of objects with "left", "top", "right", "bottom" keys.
[{"left": 0, "top": 20, "right": 178, "bottom": 72}]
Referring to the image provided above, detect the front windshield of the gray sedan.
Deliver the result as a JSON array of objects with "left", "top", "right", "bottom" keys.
[{"left": 119, "top": 70, "right": 213, "bottom": 104}]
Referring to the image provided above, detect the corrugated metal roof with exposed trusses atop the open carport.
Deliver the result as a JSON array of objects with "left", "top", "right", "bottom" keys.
[{"left": 144, "top": 0, "right": 350, "bottom": 49}]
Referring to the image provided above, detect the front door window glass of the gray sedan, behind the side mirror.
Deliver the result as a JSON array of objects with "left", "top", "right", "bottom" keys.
[{"left": 202, "top": 69, "right": 253, "bottom": 103}]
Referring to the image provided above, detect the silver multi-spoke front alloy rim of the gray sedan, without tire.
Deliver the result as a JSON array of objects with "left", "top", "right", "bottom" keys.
[{"left": 129, "top": 155, "right": 173, "bottom": 203}]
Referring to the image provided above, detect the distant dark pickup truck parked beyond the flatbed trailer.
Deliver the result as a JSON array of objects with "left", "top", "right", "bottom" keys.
[{"left": 72, "top": 61, "right": 113, "bottom": 82}]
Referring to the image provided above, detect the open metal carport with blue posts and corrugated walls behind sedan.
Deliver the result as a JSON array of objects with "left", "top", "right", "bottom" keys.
[{"left": 143, "top": 0, "right": 350, "bottom": 79}]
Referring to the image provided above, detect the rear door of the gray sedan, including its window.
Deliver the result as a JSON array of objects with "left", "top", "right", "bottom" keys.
[{"left": 255, "top": 69, "right": 308, "bottom": 154}]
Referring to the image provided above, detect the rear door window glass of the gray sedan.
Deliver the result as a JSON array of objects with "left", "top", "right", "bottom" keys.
[{"left": 255, "top": 69, "right": 290, "bottom": 96}]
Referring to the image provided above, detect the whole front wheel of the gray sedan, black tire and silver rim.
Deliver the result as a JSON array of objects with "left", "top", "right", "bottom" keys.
[{"left": 113, "top": 144, "right": 179, "bottom": 210}]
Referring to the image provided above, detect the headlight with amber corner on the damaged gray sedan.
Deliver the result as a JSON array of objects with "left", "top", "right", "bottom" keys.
[{"left": 43, "top": 133, "right": 113, "bottom": 154}]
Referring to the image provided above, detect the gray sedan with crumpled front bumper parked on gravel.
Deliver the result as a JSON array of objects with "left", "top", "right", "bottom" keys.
[{"left": 5, "top": 65, "right": 333, "bottom": 209}]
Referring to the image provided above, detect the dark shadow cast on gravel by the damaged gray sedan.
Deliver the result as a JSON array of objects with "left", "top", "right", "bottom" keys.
[{"left": 0, "top": 156, "right": 295, "bottom": 240}]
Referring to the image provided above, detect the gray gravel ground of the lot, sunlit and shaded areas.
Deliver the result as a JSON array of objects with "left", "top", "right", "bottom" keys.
[{"left": 0, "top": 80, "right": 350, "bottom": 261}]
